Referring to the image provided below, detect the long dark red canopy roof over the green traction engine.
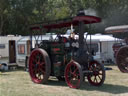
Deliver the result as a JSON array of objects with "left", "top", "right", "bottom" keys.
[{"left": 31, "top": 16, "right": 101, "bottom": 30}]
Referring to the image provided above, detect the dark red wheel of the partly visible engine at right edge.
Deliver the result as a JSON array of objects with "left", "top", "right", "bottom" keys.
[{"left": 116, "top": 46, "right": 128, "bottom": 73}]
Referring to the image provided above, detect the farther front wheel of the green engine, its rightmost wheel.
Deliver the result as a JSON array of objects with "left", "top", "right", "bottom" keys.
[{"left": 87, "top": 61, "right": 105, "bottom": 86}]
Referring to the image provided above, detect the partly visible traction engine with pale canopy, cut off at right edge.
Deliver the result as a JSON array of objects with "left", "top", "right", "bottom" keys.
[{"left": 105, "top": 25, "right": 128, "bottom": 73}]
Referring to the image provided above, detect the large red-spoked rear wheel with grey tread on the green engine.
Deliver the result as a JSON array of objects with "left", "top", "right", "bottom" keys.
[{"left": 29, "top": 48, "right": 51, "bottom": 83}]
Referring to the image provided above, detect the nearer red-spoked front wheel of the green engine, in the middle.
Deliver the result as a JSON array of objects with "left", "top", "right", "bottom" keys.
[{"left": 65, "top": 62, "right": 81, "bottom": 88}]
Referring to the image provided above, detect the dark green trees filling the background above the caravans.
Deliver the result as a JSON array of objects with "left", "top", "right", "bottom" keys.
[{"left": 0, "top": 0, "right": 128, "bottom": 35}]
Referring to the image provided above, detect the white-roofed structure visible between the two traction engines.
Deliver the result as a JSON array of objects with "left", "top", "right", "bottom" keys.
[{"left": 87, "top": 34, "right": 117, "bottom": 63}]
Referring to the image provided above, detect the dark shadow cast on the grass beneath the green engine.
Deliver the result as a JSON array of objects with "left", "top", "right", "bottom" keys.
[{"left": 46, "top": 80, "right": 128, "bottom": 94}]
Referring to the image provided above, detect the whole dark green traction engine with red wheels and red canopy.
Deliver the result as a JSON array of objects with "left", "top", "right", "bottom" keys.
[{"left": 29, "top": 13, "right": 105, "bottom": 88}]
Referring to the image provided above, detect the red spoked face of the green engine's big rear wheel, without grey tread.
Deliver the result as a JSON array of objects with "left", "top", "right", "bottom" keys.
[{"left": 29, "top": 50, "right": 46, "bottom": 83}]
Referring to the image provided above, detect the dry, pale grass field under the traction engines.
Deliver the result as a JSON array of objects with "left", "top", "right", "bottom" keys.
[{"left": 0, "top": 66, "right": 128, "bottom": 96}]
